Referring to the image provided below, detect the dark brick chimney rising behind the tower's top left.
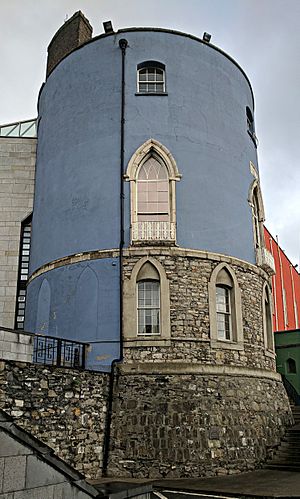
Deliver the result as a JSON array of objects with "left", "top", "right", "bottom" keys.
[{"left": 46, "top": 10, "right": 93, "bottom": 78}]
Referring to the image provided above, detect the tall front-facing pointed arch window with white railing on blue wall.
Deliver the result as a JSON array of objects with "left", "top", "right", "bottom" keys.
[{"left": 126, "top": 139, "right": 181, "bottom": 244}]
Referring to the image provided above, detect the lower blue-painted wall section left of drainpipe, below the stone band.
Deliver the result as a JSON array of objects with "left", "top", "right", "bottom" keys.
[{"left": 25, "top": 258, "right": 120, "bottom": 370}]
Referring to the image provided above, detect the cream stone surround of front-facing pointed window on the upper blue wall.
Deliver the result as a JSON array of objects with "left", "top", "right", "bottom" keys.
[{"left": 124, "top": 139, "right": 181, "bottom": 244}]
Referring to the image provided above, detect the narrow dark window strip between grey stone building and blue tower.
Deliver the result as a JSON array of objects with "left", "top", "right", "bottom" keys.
[{"left": 15, "top": 215, "right": 32, "bottom": 330}]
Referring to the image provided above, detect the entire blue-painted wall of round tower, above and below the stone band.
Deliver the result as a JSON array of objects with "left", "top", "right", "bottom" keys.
[{"left": 25, "top": 30, "right": 257, "bottom": 365}]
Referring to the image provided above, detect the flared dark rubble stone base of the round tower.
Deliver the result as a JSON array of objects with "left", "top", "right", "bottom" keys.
[{"left": 108, "top": 374, "right": 291, "bottom": 478}]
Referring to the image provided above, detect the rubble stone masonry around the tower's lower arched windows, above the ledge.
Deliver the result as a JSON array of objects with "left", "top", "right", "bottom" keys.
[{"left": 124, "top": 248, "right": 275, "bottom": 371}]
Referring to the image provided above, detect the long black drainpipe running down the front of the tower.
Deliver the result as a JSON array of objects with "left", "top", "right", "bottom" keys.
[{"left": 102, "top": 38, "right": 128, "bottom": 476}]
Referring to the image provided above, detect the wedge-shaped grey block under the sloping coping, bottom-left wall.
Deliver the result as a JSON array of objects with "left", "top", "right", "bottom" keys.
[{"left": 26, "top": 455, "right": 65, "bottom": 489}]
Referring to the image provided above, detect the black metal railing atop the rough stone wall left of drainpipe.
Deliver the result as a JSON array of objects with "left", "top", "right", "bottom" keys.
[{"left": 33, "top": 335, "right": 87, "bottom": 369}]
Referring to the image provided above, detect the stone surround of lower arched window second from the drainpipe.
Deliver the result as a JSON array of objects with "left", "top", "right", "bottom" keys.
[{"left": 208, "top": 262, "right": 244, "bottom": 350}]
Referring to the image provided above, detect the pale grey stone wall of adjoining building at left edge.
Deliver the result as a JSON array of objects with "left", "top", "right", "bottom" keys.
[{"left": 0, "top": 137, "right": 36, "bottom": 328}]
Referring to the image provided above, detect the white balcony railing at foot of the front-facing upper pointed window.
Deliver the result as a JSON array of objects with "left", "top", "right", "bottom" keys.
[{"left": 132, "top": 222, "right": 176, "bottom": 241}]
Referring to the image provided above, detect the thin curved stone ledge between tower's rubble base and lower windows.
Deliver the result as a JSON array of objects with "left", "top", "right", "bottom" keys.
[{"left": 118, "top": 362, "right": 281, "bottom": 381}]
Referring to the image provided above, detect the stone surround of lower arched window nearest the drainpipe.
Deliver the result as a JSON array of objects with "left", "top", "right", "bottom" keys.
[{"left": 123, "top": 256, "right": 171, "bottom": 347}]
